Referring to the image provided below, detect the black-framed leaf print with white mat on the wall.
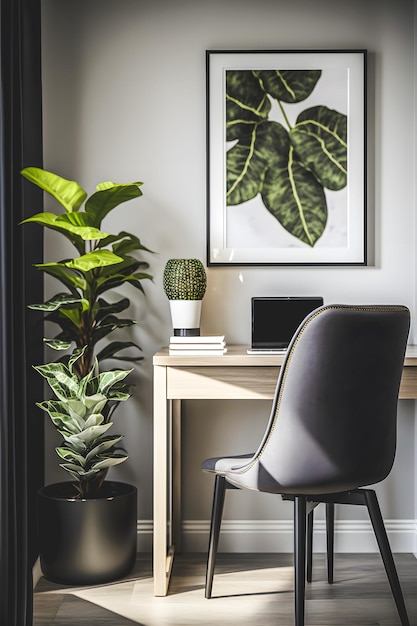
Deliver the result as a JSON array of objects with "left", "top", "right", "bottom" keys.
[{"left": 206, "top": 50, "right": 366, "bottom": 266}]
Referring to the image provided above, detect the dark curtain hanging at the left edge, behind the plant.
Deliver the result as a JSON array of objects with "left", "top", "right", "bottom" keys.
[{"left": 0, "top": 0, "right": 43, "bottom": 626}]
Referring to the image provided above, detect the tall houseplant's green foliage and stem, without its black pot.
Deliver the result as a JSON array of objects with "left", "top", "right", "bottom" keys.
[{"left": 22, "top": 167, "right": 152, "bottom": 498}]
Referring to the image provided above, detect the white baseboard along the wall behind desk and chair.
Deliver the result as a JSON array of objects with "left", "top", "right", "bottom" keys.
[{"left": 138, "top": 519, "right": 417, "bottom": 557}]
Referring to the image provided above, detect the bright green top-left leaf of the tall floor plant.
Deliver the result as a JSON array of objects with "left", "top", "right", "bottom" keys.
[{"left": 21, "top": 167, "right": 87, "bottom": 212}]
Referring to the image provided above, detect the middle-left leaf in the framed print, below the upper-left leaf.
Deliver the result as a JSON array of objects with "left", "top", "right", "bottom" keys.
[{"left": 226, "top": 122, "right": 289, "bottom": 206}]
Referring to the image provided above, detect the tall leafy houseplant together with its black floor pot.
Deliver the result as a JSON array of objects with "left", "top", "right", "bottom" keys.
[{"left": 22, "top": 167, "right": 152, "bottom": 584}]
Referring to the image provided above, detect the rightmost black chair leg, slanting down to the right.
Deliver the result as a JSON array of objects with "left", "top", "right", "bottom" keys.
[{"left": 363, "top": 489, "right": 410, "bottom": 626}]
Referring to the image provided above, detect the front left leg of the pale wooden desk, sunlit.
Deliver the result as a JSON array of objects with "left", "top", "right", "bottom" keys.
[{"left": 153, "top": 366, "right": 172, "bottom": 596}]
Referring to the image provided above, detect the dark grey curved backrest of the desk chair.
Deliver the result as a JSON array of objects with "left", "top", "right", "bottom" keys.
[{"left": 242, "top": 305, "right": 410, "bottom": 494}]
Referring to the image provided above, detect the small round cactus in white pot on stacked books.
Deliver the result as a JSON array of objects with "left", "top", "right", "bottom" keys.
[{"left": 163, "top": 259, "right": 207, "bottom": 337}]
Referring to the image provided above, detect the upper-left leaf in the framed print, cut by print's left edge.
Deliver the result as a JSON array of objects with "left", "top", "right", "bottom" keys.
[{"left": 226, "top": 70, "right": 271, "bottom": 141}]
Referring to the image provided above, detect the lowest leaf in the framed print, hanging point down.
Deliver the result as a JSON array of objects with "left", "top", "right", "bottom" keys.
[{"left": 262, "top": 148, "right": 327, "bottom": 246}]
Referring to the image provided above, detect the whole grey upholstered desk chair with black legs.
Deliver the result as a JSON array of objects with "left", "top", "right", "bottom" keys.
[{"left": 202, "top": 305, "right": 410, "bottom": 626}]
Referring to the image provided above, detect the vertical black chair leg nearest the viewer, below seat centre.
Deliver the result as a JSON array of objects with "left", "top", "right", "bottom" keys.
[{"left": 294, "top": 496, "right": 307, "bottom": 626}]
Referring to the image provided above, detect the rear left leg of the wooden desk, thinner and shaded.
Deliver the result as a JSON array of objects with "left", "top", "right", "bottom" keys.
[{"left": 172, "top": 400, "right": 182, "bottom": 552}]
